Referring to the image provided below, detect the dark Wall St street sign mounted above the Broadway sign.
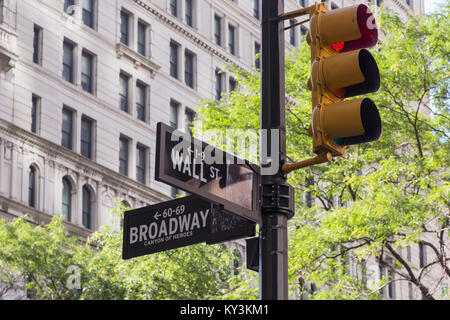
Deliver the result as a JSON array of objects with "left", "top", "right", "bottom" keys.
[{"left": 155, "top": 122, "right": 261, "bottom": 223}]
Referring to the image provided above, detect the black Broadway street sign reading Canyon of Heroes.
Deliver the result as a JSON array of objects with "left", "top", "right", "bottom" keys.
[{"left": 122, "top": 196, "right": 256, "bottom": 259}]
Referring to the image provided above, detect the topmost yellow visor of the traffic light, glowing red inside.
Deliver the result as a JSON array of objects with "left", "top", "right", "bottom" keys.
[{"left": 319, "top": 4, "right": 378, "bottom": 52}]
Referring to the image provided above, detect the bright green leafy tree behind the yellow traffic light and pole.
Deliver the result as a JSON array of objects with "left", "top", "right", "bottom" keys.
[{"left": 197, "top": 5, "right": 450, "bottom": 299}]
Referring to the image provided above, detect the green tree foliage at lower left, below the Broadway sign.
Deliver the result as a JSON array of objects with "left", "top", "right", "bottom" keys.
[{"left": 0, "top": 202, "right": 239, "bottom": 300}]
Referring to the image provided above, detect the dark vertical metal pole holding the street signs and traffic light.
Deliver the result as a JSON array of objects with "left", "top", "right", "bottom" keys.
[{"left": 259, "top": 0, "right": 291, "bottom": 300}]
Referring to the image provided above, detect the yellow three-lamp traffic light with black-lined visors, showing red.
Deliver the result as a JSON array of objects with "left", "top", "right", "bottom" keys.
[{"left": 307, "top": 3, "right": 382, "bottom": 158}]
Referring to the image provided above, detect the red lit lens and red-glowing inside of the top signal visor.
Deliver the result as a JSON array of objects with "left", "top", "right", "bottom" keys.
[{"left": 331, "top": 4, "right": 378, "bottom": 52}]
